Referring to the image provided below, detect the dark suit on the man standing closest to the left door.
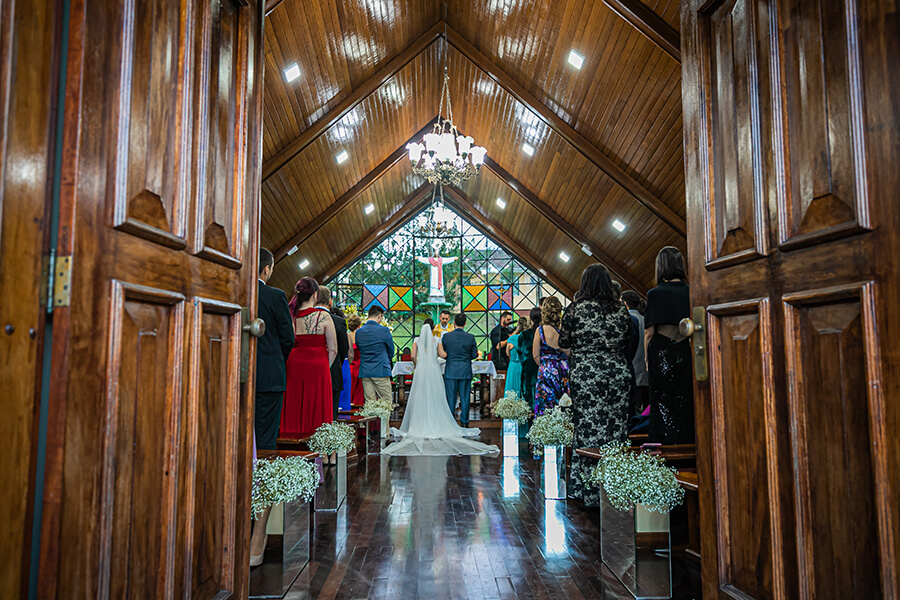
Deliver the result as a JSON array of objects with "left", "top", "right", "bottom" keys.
[{"left": 254, "top": 281, "right": 294, "bottom": 450}]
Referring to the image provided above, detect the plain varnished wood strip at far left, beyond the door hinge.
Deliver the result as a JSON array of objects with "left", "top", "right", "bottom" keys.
[{"left": 0, "top": 0, "right": 60, "bottom": 598}]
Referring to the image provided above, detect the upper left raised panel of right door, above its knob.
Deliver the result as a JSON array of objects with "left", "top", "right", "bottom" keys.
[{"left": 699, "top": 0, "right": 769, "bottom": 268}]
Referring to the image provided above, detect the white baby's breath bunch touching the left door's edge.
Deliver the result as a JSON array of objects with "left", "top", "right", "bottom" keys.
[{"left": 250, "top": 456, "right": 319, "bottom": 517}]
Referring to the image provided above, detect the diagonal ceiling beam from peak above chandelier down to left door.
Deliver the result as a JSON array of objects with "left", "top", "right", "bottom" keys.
[{"left": 263, "top": 21, "right": 444, "bottom": 181}]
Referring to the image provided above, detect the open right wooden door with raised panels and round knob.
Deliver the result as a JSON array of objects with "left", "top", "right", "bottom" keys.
[{"left": 681, "top": 0, "right": 900, "bottom": 600}]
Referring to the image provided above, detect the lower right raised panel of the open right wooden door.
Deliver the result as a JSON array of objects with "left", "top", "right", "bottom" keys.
[{"left": 783, "top": 281, "right": 898, "bottom": 599}]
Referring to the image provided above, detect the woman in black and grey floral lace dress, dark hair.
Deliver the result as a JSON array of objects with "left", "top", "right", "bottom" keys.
[{"left": 559, "top": 264, "right": 631, "bottom": 506}]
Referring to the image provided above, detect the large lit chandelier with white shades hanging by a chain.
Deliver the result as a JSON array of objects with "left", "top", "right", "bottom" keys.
[{"left": 406, "top": 68, "right": 487, "bottom": 185}]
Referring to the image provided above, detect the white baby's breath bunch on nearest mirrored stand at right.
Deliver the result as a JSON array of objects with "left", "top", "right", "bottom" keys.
[{"left": 584, "top": 442, "right": 684, "bottom": 513}]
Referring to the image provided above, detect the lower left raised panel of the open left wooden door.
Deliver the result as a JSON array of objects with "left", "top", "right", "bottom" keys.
[{"left": 97, "top": 280, "right": 185, "bottom": 598}]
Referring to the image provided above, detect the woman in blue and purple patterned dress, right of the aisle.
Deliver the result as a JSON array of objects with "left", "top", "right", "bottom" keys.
[{"left": 531, "top": 296, "right": 569, "bottom": 415}]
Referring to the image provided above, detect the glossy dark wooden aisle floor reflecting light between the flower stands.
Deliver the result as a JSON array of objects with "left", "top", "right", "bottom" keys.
[{"left": 286, "top": 429, "right": 631, "bottom": 600}]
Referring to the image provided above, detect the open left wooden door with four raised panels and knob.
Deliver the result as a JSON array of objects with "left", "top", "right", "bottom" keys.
[{"left": 40, "top": 0, "right": 263, "bottom": 599}]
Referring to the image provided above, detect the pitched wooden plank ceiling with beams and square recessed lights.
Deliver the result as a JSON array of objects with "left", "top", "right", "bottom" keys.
[{"left": 261, "top": 0, "right": 685, "bottom": 292}]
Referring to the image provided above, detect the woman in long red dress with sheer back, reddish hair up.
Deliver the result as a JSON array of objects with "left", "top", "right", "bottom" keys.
[{"left": 281, "top": 277, "right": 337, "bottom": 439}]
